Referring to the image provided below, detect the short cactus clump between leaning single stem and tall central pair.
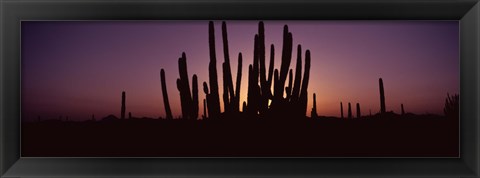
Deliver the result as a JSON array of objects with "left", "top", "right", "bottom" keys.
[{"left": 177, "top": 53, "right": 198, "bottom": 120}]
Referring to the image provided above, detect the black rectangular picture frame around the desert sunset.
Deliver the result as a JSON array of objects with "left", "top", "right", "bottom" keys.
[{"left": 0, "top": 0, "right": 480, "bottom": 177}]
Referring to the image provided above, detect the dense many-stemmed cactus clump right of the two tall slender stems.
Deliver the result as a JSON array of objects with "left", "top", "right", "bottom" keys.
[{"left": 242, "top": 22, "right": 310, "bottom": 118}]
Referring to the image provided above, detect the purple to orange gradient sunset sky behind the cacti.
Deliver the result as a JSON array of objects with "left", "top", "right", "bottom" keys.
[{"left": 21, "top": 21, "right": 460, "bottom": 120}]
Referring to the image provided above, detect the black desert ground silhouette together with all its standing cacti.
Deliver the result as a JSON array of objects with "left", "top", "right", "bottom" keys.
[{"left": 21, "top": 22, "right": 459, "bottom": 157}]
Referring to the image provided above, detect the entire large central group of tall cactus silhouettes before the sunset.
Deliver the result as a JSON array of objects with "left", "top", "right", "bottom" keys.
[{"left": 160, "top": 22, "right": 316, "bottom": 119}]
